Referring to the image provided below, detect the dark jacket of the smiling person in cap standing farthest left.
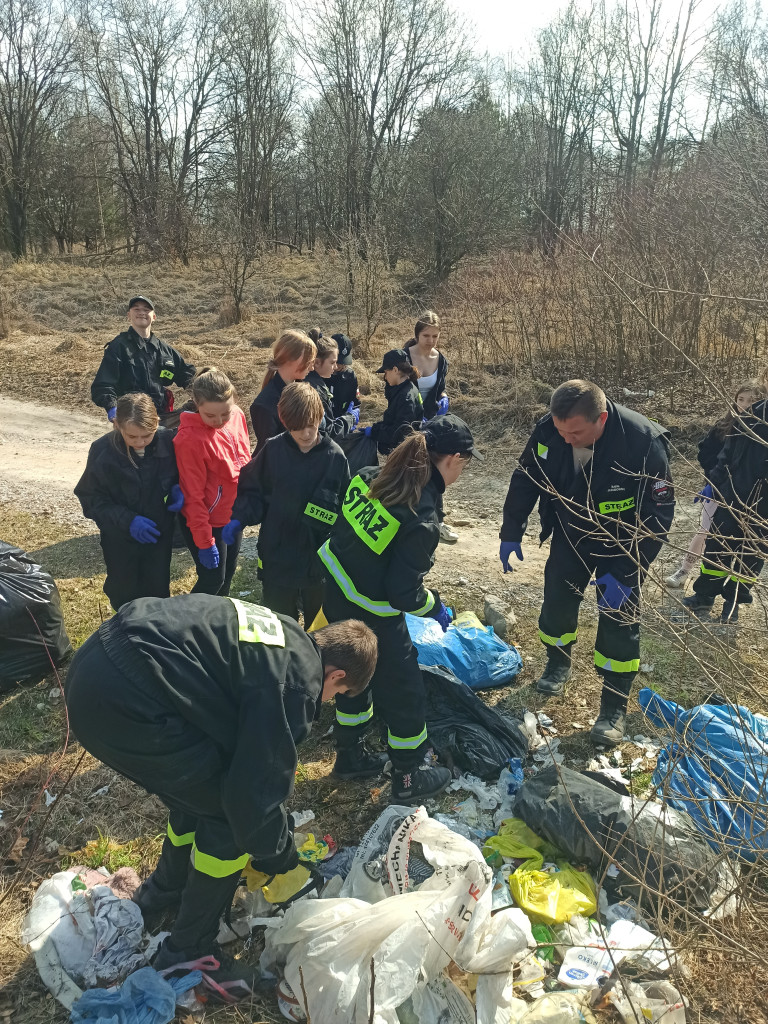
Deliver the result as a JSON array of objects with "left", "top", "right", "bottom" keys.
[{"left": 91, "top": 327, "right": 195, "bottom": 413}]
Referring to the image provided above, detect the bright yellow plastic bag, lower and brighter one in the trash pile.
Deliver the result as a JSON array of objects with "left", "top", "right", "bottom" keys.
[{"left": 509, "top": 860, "right": 597, "bottom": 925}]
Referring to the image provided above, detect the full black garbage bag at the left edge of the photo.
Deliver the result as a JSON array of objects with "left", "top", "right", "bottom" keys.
[{"left": 0, "top": 541, "right": 72, "bottom": 691}]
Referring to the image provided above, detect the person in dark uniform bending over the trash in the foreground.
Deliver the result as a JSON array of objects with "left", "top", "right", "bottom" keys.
[{"left": 66, "top": 594, "right": 377, "bottom": 989}]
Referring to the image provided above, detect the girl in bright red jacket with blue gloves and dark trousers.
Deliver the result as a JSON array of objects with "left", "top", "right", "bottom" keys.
[{"left": 173, "top": 367, "right": 251, "bottom": 597}]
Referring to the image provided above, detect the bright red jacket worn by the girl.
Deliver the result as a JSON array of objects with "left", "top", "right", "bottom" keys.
[{"left": 173, "top": 406, "right": 251, "bottom": 548}]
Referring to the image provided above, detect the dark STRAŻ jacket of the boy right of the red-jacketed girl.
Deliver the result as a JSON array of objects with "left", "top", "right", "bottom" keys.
[{"left": 232, "top": 432, "right": 349, "bottom": 587}]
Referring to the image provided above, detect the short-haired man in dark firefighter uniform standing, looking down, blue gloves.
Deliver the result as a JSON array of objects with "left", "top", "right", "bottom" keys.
[{"left": 499, "top": 380, "right": 675, "bottom": 745}]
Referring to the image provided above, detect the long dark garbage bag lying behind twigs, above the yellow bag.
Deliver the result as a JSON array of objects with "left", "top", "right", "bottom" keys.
[{"left": 513, "top": 765, "right": 725, "bottom": 910}]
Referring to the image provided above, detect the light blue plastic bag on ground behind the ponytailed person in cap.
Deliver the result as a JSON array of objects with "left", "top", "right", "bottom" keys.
[{"left": 406, "top": 614, "right": 522, "bottom": 690}]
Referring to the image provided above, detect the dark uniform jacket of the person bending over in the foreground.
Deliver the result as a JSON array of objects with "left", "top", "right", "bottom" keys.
[{"left": 94, "top": 594, "right": 324, "bottom": 859}]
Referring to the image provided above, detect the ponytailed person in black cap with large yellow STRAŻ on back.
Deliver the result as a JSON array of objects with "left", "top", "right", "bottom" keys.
[{"left": 318, "top": 415, "right": 483, "bottom": 804}]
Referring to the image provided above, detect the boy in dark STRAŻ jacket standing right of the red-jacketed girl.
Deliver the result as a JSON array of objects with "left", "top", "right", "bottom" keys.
[{"left": 223, "top": 382, "right": 349, "bottom": 629}]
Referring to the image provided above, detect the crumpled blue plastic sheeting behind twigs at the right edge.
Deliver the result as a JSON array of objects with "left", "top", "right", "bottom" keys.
[{"left": 638, "top": 689, "right": 768, "bottom": 862}]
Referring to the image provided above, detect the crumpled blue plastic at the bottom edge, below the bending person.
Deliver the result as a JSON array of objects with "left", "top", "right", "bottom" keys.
[{"left": 72, "top": 967, "right": 203, "bottom": 1024}]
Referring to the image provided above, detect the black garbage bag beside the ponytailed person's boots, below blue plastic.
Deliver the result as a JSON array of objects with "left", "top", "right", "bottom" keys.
[{"left": 421, "top": 666, "right": 528, "bottom": 779}]
